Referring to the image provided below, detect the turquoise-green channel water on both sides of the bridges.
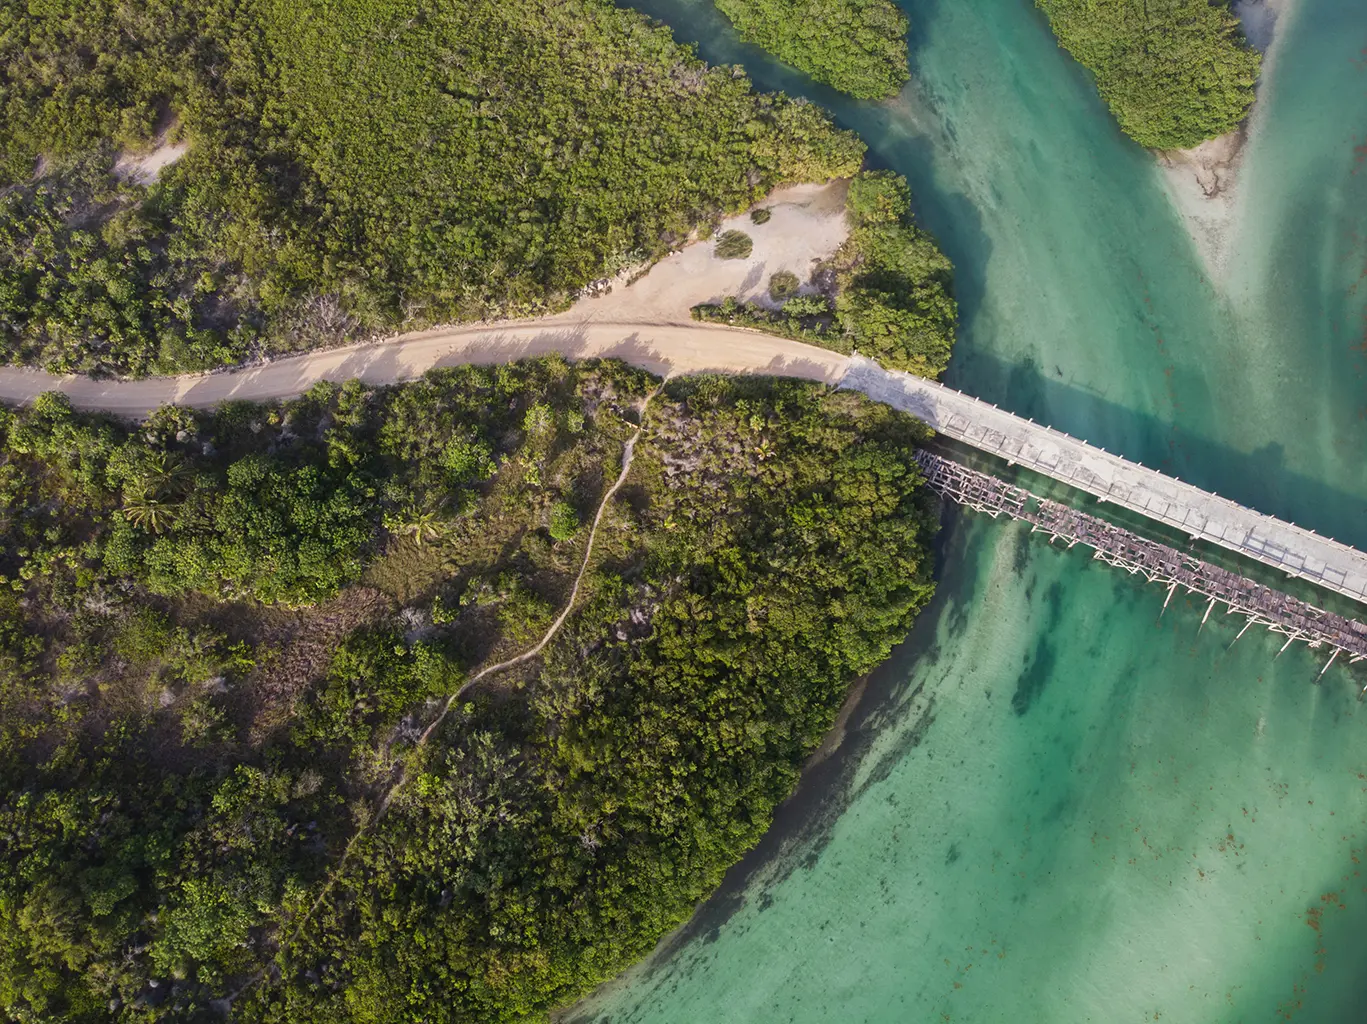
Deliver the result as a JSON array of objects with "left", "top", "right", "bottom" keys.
[{"left": 574, "top": 0, "right": 1367, "bottom": 1024}]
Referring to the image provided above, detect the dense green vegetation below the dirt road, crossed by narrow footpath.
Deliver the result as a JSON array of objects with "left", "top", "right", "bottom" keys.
[{"left": 0, "top": 360, "right": 934, "bottom": 1024}]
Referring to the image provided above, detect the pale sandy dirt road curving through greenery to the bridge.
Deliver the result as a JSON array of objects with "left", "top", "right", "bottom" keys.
[{"left": 0, "top": 320, "right": 849, "bottom": 416}]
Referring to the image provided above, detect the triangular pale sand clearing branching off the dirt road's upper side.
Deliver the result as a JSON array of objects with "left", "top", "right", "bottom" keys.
[{"left": 555, "top": 180, "right": 849, "bottom": 324}]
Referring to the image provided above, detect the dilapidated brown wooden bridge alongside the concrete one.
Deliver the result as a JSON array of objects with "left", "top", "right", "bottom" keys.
[{"left": 916, "top": 451, "right": 1367, "bottom": 675}]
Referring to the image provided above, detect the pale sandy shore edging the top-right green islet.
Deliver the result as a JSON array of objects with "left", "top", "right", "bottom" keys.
[{"left": 1155, "top": 0, "right": 1299, "bottom": 278}]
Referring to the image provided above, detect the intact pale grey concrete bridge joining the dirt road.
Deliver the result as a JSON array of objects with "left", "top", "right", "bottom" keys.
[{"left": 841, "top": 355, "right": 1367, "bottom": 603}]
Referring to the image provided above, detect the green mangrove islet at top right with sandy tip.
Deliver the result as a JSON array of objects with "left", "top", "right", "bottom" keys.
[{"left": 1036, "top": 0, "right": 1260, "bottom": 149}]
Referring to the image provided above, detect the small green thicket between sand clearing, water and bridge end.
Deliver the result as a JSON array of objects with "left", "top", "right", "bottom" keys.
[{"left": 693, "top": 171, "right": 958, "bottom": 377}]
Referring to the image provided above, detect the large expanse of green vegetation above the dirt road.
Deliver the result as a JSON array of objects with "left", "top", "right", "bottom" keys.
[{"left": 0, "top": 0, "right": 863, "bottom": 375}]
